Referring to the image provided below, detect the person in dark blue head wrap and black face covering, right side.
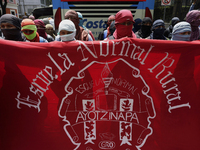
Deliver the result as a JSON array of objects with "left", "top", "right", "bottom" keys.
[{"left": 147, "top": 19, "right": 168, "bottom": 40}]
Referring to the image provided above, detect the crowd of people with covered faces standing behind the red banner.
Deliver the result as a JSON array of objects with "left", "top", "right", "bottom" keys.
[{"left": 0, "top": 5, "right": 200, "bottom": 42}]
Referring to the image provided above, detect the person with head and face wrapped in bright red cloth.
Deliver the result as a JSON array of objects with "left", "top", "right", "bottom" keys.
[{"left": 107, "top": 9, "right": 136, "bottom": 40}]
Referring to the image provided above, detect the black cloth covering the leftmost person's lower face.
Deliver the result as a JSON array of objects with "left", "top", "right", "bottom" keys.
[{"left": 1, "top": 29, "right": 22, "bottom": 41}]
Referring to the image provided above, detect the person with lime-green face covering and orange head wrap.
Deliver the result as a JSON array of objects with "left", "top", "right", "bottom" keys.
[{"left": 21, "top": 19, "right": 48, "bottom": 42}]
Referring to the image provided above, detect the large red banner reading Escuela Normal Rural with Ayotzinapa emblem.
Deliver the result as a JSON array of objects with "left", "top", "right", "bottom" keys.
[{"left": 0, "top": 38, "right": 200, "bottom": 150}]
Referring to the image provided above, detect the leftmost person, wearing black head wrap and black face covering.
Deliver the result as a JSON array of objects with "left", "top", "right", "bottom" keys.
[{"left": 0, "top": 14, "right": 26, "bottom": 41}]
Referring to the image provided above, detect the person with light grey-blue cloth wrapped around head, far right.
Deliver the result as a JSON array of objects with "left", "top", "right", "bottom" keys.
[{"left": 171, "top": 21, "right": 192, "bottom": 41}]
